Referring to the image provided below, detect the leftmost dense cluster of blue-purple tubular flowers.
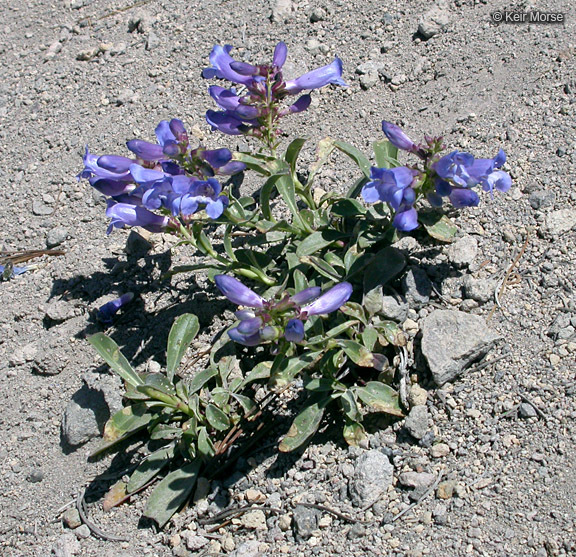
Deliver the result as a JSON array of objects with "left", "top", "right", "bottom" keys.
[{"left": 78, "top": 118, "right": 245, "bottom": 233}]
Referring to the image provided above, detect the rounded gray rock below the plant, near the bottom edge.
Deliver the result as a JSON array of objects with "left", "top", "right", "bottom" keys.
[{"left": 349, "top": 449, "right": 394, "bottom": 507}]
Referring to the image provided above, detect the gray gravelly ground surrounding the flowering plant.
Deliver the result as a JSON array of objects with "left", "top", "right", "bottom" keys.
[{"left": 0, "top": 0, "right": 576, "bottom": 557}]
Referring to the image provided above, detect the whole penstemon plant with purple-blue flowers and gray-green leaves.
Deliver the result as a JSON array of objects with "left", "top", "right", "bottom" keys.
[{"left": 79, "top": 42, "right": 511, "bottom": 527}]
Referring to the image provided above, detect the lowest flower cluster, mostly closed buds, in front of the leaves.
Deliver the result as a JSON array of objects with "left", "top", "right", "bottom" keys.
[{"left": 214, "top": 275, "right": 352, "bottom": 346}]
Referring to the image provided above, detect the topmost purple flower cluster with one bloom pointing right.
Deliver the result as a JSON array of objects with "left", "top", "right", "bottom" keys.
[{"left": 202, "top": 42, "right": 346, "bottom": 147}]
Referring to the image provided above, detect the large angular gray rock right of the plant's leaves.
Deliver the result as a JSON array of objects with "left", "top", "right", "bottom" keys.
[{"left": 421, "top": 310, "right": 500, "bottom": 386}]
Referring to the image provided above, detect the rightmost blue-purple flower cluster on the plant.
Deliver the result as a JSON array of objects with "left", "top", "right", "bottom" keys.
[{"left": 362, "top": 121, "right": 512, "bottom": 232}]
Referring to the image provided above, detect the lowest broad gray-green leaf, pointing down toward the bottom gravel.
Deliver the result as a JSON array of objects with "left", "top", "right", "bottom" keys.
[{"left": 144, "top": 458, "right": 202, "bottom": 528}]
